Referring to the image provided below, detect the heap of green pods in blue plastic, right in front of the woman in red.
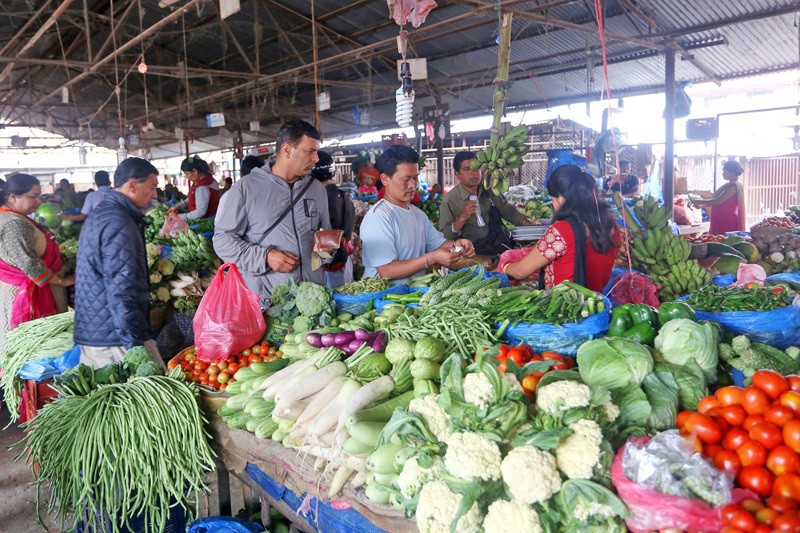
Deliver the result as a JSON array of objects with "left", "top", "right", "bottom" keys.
[{"left": 484, "top": 281, "right": 605, "bottom": 325}]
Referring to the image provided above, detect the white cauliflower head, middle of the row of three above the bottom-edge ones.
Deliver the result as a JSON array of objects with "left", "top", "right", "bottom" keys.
[{"left": 500, "top": 446, "right": 561, "bottom": 504}]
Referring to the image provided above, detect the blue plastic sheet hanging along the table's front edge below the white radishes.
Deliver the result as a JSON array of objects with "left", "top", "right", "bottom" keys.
[{"left": 245, "top": 463, "right": 385, "bottom": 533}]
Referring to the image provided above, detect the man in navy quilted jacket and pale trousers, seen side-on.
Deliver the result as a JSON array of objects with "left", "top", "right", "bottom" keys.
[{"left": 74, "top": 157, "right": 163, "bottom": 368}]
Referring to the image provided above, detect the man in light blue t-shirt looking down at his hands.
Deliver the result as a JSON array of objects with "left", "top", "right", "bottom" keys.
[{"left": 360, "top": 145, "right": 475, "bottom": 283}]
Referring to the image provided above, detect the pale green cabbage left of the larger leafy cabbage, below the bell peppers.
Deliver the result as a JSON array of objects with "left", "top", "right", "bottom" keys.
[{"left": 578, "top": 337, "right": 653, "bottom": 390}]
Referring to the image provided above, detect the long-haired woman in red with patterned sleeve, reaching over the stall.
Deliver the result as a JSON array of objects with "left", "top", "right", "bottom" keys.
[{"left": 503, "top": 165, "right": 620, "bottom": 292}]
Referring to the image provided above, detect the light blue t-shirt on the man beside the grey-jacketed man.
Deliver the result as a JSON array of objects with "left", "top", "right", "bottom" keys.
[{"left": 360, "top": 200, "right": 447, "bottom": 284}]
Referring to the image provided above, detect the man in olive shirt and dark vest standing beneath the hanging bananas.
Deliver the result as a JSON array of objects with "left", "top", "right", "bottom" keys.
[{"left": 439, "top": 151, "right": 533, "bottom": 260}]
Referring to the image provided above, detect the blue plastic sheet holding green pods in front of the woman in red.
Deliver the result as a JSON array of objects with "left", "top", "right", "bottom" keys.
[{"left": 505, "top": 296, "right": 611, "bottom": 356}]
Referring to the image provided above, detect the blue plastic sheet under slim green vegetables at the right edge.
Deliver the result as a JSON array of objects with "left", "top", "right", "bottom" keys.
[{"left": 679, "top": 296, "right": 800, "bottom": 350}]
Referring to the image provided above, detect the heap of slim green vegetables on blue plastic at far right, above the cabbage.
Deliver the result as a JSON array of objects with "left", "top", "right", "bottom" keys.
[{"left": 686, "top": 285, "right": 791, "bottom": 312}]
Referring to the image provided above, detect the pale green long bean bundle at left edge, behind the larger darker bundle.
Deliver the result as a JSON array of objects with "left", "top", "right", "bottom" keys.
[{"left": 0, "top": 313, "right": 75, "bottom": 422}]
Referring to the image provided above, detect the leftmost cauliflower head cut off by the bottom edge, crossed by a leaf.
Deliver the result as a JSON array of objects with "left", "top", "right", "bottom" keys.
[{"left": 417, "top": 480, "right": 483, "bottom": 533}]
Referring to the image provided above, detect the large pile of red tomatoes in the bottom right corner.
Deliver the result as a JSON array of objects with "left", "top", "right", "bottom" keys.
[{"left": 678, "top": 370, "right": 800, "bottom": 533}]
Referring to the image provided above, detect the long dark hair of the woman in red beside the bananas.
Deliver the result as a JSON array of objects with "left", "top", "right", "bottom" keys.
[{"left": 547, "top": 165, "right": 617, "bottom": 254}]
